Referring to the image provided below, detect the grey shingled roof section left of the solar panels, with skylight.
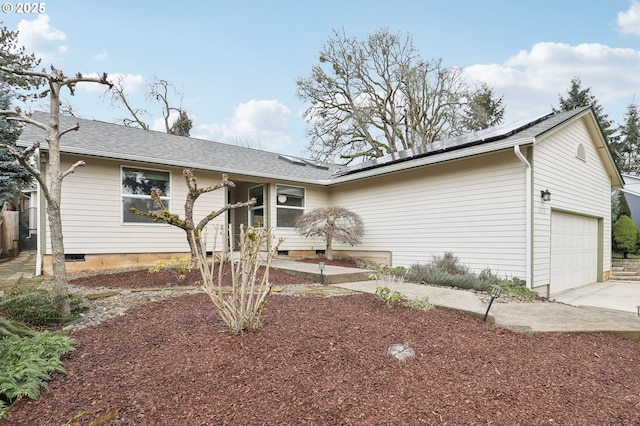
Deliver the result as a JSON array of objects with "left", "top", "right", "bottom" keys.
[{"left": 19, "top": 112, "right": 337, "bottom": 183}]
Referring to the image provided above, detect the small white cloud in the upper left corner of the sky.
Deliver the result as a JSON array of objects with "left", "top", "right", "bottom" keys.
[{"left": 18, "top": 15, "right": 68, "bottom": 63}]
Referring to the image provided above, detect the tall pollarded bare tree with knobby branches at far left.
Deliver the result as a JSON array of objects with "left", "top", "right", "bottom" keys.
[{"left": 0, "top": 66, "right": 111, "bottom": 314}]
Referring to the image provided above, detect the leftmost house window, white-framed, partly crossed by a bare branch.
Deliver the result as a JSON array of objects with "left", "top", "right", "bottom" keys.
[{"left": 121, "top": 167, "right": 171, "bottom": 223}]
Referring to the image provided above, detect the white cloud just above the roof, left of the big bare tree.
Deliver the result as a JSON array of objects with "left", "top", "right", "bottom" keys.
[{"left": 191, "top": 99, "right": 292, "bottom": 152}]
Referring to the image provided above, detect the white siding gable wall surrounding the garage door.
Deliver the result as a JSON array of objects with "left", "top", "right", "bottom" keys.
[{"left": 533, "top": 121, "right": 611, "bottom": 287}]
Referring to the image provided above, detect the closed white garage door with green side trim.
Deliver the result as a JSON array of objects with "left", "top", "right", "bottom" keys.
[{"left": 549, "top": 212, "right": 598, "bottom": 294}]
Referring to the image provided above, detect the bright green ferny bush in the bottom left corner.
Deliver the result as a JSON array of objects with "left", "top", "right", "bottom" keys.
[{"left": 0, "top": 331, "right": 74, "bottom": 418}]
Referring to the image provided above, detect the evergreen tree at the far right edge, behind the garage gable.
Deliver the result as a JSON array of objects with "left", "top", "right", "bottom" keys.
[{"left": 611, "top": 102, "right": 640, "bottom": 175}]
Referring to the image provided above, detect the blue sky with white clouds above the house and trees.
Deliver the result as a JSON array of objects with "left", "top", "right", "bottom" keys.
[{"left": 0, "top": 0, "right": 640, "bottom": 155}]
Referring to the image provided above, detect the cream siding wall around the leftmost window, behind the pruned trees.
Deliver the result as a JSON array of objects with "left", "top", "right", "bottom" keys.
[{"left": 46, "top": 157, "right": 225, "bottom": 254}]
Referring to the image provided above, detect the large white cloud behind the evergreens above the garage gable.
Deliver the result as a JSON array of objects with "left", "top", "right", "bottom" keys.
[{"left": 464, "top": 43, "right": 640, "bottom": 121}]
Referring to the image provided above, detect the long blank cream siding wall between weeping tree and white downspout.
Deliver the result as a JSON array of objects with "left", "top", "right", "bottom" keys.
[{"left": 331, "top": 151, "right": 525, "bottom": 278}]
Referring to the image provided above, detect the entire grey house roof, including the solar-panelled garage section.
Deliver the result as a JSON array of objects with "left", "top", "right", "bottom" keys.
[{"left": 19, "top": 107, "right": 624, "bottom": 187}]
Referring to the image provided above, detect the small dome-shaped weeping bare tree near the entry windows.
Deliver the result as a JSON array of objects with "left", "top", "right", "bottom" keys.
[{"left": 295, "top": 206, "right": 364, "bottom": 260}]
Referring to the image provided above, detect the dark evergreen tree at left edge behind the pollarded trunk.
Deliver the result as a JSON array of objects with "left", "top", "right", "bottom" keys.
[{"left": 0, "top": 83, "right": 33, "bottom": 207}]
